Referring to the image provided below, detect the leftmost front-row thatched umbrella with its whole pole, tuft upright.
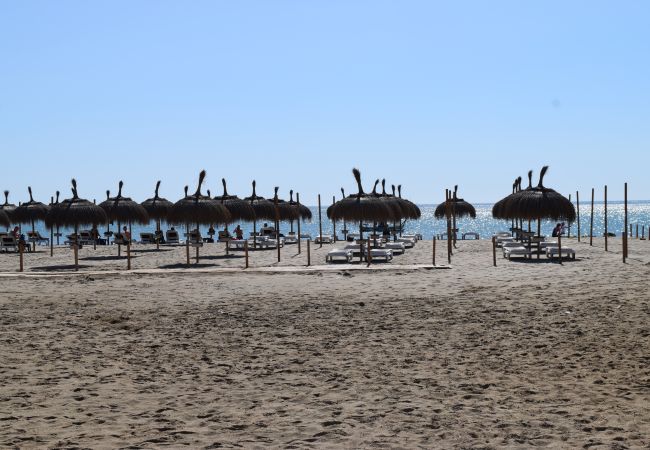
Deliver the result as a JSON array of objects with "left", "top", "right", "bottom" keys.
[{"left": 47, "top": 178, "right": 108, "bottom": 270}]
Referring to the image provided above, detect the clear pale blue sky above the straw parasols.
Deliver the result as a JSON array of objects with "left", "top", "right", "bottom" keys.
[{"left": 0, "top": 0, "right": 650, "bottom": 204}]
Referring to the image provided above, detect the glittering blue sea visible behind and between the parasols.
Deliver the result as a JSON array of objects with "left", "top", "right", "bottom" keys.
[{"left": 11, "top": 200, "right": 650, "bottom": 243}]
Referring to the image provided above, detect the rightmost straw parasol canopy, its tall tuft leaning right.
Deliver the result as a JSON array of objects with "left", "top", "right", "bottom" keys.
[{"left": 496, "top": 166, "right": 576, "bottom": 222}]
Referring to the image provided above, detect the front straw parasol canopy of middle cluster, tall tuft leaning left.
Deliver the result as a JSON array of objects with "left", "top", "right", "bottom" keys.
[{"left": 327, "top": 169, "right": 393, "bottom": 222}]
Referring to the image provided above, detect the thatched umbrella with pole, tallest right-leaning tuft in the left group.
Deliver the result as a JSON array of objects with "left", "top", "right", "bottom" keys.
[{"left": 169, "top": 170, "right": 231, "bottom": 265}]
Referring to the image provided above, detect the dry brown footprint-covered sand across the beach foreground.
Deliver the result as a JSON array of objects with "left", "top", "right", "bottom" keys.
[{"left": 0, "top": 239, "right": 650, "bottom": 448}]
